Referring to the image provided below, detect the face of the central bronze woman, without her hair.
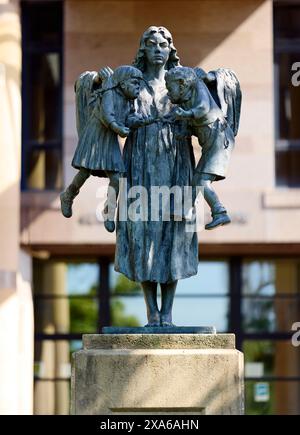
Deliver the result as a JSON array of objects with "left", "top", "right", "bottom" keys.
[{"left": 145, "top": 33, "right": 171, "bottom": 65}]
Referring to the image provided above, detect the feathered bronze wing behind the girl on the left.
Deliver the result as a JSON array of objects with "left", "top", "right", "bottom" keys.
[{"left": 74, "top": 71, "right": 97, "bottom": 137}]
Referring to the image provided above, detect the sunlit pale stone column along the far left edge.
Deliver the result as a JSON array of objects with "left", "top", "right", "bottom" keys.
[{"left": 0, "top": 0, "right": 33, "bottom": 415}]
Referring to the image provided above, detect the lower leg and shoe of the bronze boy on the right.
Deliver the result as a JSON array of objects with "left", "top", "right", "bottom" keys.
[{"left": 193, "top": 172, "right": 230, "bottom": 230}]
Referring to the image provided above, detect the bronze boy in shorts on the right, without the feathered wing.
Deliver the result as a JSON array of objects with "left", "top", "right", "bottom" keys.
[{"left": 165, "top": 67, "right": 240, "bottom": 230}]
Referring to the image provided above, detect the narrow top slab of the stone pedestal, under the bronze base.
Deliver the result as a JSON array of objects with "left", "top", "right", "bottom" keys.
[{"left": 83, "top": 333, "right": 235, "bottom": 350}]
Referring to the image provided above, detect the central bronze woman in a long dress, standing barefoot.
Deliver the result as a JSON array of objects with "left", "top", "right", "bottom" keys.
[{"left": 103, "top": 26, "right": 198, "bottom": 326}]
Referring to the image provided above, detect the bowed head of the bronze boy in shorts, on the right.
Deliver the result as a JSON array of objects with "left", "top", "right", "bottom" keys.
[{"left": 165, "top": 67, "right": 198, "bottom": 103}]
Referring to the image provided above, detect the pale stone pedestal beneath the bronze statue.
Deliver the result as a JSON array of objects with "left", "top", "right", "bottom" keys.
[{"left": 71, "top": 334, "right": 244, "bottom": 415}]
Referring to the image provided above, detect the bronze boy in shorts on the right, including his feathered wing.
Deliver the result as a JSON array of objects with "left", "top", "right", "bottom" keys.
[{"left": 165, "top": 67, "right": 241, "bottom": 230}]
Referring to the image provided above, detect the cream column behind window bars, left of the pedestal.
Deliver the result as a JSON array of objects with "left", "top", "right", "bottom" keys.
[{"left": 34, "top": 260, "right": 70, "bottom": 415}]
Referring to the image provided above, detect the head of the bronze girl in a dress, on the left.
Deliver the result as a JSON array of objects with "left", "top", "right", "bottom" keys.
[{"left": 112, "top": 65, "right": 143, "bottom": 100}]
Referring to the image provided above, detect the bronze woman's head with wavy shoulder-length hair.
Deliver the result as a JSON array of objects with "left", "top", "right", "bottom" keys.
[{"left": 133, "top": 26, "right": 180, "bottom": 72}]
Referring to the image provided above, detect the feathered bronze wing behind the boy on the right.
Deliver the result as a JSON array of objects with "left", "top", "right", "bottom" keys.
[{"left": 208, "top": 68, "right": 242, "bottom": 136}]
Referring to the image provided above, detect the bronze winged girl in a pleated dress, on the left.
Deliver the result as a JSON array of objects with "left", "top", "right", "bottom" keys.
[{"left": 60, "top": 65, "right": 148, "bottom": 232}]
